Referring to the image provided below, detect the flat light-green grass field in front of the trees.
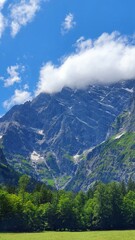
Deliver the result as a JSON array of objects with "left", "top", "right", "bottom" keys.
[{"left": 0, "top": 231, "right": 135, "bottom": 240}]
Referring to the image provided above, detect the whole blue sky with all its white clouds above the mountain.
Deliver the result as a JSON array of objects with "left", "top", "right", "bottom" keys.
[{"left": 0, "top": 0, "right": 135, "bottom": 116}]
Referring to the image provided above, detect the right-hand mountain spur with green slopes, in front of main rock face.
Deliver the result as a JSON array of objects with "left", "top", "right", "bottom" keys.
[{"left": 67, "top": 92, "right": 135, "bottom": 191}]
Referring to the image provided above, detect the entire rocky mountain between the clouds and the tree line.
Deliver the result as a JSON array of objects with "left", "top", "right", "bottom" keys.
[{"left": 0, "top": 81, "right": 135, "bottom": 191}]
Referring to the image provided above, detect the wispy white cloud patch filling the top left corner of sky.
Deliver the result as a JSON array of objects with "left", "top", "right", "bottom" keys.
[{"left": 0, "top": 0, "right": 47, "bottom": 38}]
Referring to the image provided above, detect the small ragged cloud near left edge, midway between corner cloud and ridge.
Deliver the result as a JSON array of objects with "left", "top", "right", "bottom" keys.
[{"left": 1, "top": 65, "right": 25, "bottom": 87}]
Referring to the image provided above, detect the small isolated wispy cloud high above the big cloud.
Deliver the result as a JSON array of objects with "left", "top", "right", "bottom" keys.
[{"left": 61, "top": 13, "right": 76, "bottom": 34}]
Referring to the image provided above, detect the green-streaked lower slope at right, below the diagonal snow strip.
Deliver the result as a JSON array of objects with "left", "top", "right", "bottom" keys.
[{"left": 67, "top": 132, "right": 135, "bottom": 191}]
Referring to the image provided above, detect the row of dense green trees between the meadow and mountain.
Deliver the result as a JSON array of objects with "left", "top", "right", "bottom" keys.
[{"left": 0, "top": 175, "right": 135, "bottom": 232}]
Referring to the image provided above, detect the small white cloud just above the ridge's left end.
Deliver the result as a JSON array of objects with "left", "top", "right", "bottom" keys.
[{"left": 3, "top": 89, "right": 32, "bottom": 109}]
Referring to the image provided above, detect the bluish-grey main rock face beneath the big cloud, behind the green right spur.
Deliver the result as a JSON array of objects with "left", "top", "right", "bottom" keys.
[{"left": 0, "top": 81, "right": 135, "bottom": 188}]
